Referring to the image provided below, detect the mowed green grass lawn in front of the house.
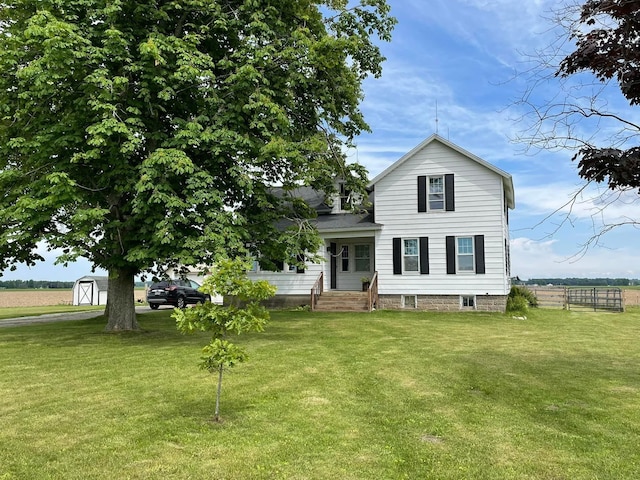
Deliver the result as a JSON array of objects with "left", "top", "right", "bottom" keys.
[{"left": 0, "top": 309, "right": 640, "bottom": 480}]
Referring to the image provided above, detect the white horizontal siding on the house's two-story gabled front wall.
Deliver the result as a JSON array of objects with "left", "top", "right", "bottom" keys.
[{"left": 375, "top": 141, "right": 508, "bottom": 295}]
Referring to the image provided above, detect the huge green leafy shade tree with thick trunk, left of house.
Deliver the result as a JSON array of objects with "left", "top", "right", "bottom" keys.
[{"left": 0, "top": 0, "right": 395, "bottom": 331}]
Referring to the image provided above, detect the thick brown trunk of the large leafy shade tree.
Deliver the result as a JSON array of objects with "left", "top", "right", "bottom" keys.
[{"left": 105, "top": 269, "right": 138, "bottom": 332}]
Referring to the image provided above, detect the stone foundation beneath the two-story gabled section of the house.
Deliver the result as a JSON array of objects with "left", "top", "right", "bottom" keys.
[{"left": 377, "top": 295, "right": 507, "bottom": 312}]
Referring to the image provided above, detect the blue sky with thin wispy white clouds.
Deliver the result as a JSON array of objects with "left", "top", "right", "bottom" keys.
[{"left": 5, "top": 0, "right": 640, "bottom": 280}]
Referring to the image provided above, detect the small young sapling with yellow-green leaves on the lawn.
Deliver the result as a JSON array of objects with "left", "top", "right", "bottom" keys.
[{"left": 173, "top": 258, "right": 276, "bottom": 421}]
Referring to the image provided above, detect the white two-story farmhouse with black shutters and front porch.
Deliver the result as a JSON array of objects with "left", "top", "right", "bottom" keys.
[{"left": 245, "top": 135, "right": 515, "bottom": 311}]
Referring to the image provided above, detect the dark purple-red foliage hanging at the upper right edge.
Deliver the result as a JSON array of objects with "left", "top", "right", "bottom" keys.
[{"left": 558, "top": 0, "right": 640, "bottom": 191}]
